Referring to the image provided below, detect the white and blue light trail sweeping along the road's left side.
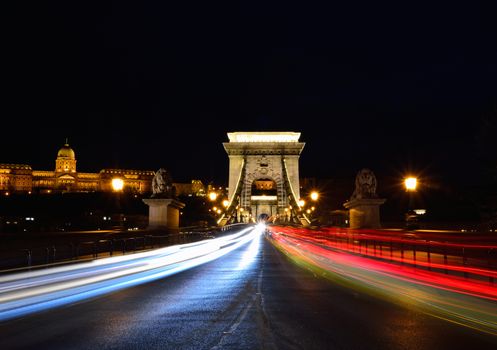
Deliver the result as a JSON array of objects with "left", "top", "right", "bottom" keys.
[{"left": 0, "top": 226, "right": 264, "bottom": 321}]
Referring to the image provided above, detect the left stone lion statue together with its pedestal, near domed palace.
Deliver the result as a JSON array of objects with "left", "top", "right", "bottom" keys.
[{"left": 143, "top": 168, "right": 185, "bottom": 231}]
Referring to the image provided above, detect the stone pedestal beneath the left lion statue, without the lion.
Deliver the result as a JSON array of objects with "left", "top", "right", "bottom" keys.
[{"left": 143, "top": 198, "right": 185, "bottom": 230}]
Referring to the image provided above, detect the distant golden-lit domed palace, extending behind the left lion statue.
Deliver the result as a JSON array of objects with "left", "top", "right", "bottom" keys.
[{"left": 0, "top": 142, "right": 205, "bottom": 195}]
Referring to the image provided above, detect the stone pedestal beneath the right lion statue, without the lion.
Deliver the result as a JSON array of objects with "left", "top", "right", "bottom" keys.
[{"left": 343, "top": 198, "right": 386, "bottom": 228}]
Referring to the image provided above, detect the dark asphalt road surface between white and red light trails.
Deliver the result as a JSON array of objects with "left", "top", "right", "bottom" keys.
[{"left": 0, "top": 231, "right": 497, "bottom": 350}]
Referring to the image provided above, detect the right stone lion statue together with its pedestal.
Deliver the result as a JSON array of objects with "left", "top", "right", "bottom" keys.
[{"left": 344, "top": 168, "right": 386, "bottom": 228}]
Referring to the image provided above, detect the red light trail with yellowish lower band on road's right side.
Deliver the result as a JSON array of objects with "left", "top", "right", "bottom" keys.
[{"left": 269, "top": 226, "right": 497, "bottom": 335}]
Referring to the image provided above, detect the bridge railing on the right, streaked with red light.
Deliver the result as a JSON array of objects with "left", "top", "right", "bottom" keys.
[{"left": 272, "top": 226, "right": 497, "bottom": 284}]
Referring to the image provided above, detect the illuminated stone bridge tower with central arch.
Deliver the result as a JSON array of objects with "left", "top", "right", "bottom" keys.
[{"left": 219, "top": 132, "right": 309, "bottom": 225}]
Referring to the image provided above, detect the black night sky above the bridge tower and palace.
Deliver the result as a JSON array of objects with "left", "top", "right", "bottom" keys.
[{"left": 0, "top": 1, "right": 497, "bottom": 187}]
